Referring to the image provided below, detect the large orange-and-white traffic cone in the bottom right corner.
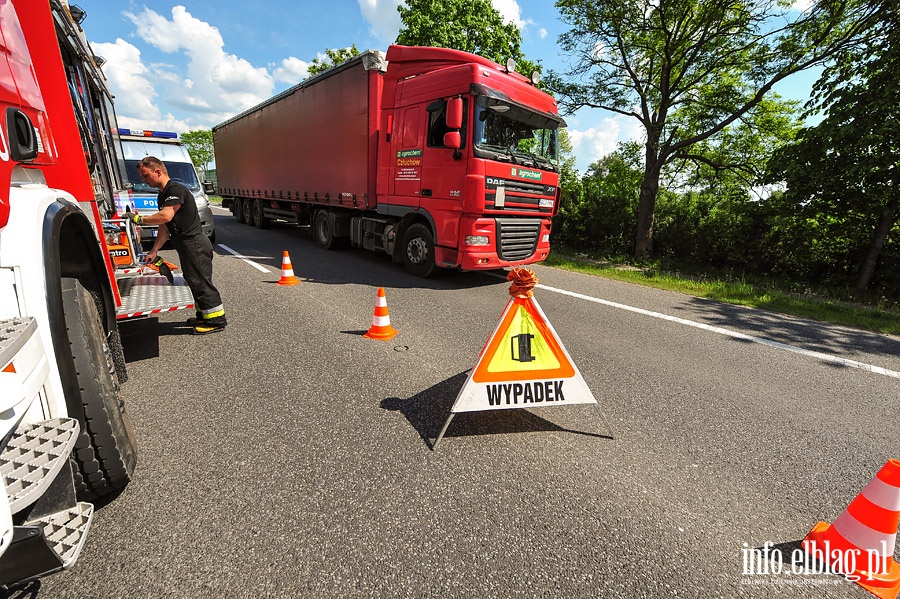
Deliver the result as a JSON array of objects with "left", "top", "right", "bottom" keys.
[{"left": 803, "top": 460, "right": 900, "bottom": 599}]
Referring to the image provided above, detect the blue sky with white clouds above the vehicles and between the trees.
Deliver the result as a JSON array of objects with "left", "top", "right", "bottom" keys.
[{"left": 70, "top": 0, "right": 814, "bottom": 174}]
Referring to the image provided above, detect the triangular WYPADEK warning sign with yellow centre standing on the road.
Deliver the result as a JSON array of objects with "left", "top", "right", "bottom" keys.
[{"left": 450, "top": 297, "right": 597, "bottom": 414}]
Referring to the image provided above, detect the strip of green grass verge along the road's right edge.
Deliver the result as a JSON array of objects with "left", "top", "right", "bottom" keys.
[{"left": 545, "top": 254, "right": 900, "bottom": 335}]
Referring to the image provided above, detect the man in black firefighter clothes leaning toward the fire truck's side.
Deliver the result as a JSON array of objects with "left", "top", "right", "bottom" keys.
[{"left": 131, "top": 156, "right": 228, "bottom": 335}]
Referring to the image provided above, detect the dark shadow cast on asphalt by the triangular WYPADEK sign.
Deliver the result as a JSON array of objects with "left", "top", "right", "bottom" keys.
[{"left": 381, "top": 371, "right": 613, "bottom": 449}]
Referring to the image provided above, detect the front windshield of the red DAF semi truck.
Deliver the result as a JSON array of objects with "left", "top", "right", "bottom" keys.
[{"left": 474, "top": 97, "right": 558, "bottom": 171}]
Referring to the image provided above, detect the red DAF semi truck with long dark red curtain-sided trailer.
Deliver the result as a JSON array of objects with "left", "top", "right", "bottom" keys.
[{"left": 213, "top": 45, "right": 565, "bottom": 277}]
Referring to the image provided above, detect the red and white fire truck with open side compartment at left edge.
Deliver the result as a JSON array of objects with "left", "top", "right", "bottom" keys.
[{"left": 0, "top": 0, "right": 193, "bottom": 589}]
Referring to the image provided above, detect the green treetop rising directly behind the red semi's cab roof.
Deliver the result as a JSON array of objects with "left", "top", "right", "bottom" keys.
[{"left": 397, "top": 0, "right": 533, "bottom": 66}]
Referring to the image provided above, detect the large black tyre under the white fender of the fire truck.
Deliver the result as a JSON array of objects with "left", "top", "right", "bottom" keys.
[{"left": 62, "top": 278, "right": 137, "bottom": 501}]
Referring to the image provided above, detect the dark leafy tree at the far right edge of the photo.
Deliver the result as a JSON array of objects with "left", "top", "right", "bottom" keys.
[{"left": 771, "top": 3, "right": 900, "bottom": 291}]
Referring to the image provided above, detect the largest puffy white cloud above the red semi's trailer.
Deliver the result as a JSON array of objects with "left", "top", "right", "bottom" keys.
[{"left": 117, "top": 6, "right": 274, "bottom": 133}]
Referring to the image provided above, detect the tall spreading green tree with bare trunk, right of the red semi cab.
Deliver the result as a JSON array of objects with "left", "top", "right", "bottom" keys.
[{"left": 547, "top": 0, "right": 875, "bottom": 256}]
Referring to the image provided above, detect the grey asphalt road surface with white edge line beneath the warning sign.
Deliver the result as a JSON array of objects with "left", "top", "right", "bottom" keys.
[{"left": 29, "top": 207, "right": 900, "bottom": 599}]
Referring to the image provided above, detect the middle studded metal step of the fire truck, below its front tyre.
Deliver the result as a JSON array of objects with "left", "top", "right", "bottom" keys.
[{"left": 0, "top": 418, "right": 79, "bottom": 514}]
